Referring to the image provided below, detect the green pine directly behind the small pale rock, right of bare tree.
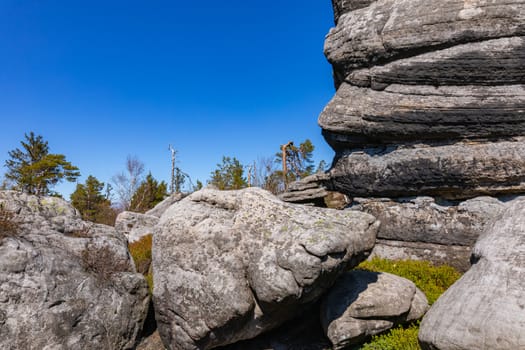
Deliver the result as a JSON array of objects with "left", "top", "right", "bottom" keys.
[{"left": 129, "top": 173, "right": 168, "bottom": 213}]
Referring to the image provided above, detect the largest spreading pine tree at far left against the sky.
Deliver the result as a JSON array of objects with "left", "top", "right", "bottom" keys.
[{"left": 5, "top": 132, "right": 80, "bottom": 196}]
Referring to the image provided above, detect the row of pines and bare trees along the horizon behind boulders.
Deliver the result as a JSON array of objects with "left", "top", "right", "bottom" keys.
[{"left": 1, "top": 132, "right": 325, "bottom": 225}]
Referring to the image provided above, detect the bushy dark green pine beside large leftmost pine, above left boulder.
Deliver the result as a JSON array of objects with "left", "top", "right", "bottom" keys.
[{"left": 70, "top": 175, "right": 116, "bottom": 225}]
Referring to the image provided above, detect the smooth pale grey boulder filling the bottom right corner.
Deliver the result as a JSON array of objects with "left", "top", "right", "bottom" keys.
[{"left": 419, "top": 199, "right": 525, "bottom": 350}]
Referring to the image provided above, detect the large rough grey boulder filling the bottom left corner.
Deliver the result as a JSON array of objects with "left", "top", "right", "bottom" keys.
[{"left": 0, "top": 191, "right": 149, "bottom": 350}]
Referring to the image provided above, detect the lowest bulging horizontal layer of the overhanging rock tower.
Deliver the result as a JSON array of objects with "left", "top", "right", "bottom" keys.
[{"left": 327, "top": 139, "right": 525, "bottom": 199}]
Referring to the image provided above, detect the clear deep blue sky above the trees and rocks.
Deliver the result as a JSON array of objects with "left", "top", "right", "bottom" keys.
[{"left": 0, "top": 0, "right": 334, "bottom": 197}]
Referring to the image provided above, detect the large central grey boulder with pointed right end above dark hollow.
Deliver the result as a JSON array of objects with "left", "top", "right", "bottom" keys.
[{"left": 153, "top": 188, "right": 378, "bottom": 349}]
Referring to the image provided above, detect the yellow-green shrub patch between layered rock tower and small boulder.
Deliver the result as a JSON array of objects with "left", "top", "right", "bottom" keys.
[{"left": 357, "top": 257, "right": 461, "bottom": 305}]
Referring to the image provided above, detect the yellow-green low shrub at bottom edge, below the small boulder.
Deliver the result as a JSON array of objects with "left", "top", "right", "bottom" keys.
[{"left": 360, "top": 324, "right": 421, "bottom": 350}]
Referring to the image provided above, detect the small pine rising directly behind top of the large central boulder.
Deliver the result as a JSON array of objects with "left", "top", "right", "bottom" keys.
[{"left": 208, "top": 157, "right": 248, "bottom": 190}]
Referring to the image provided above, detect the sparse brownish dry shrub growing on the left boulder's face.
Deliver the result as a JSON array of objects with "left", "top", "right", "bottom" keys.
[{"left": 81, "top": 245, "right": 129, "bottom": 281}]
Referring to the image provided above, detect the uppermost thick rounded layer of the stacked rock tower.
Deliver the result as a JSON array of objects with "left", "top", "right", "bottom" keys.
[{"left": 325, "top": 0, "right": 525, "bottom": 81}]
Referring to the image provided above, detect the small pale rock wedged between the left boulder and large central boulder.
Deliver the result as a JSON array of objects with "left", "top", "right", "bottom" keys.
[{"left": 115, "top": 211, "right": 159, "bottom": 242}]
